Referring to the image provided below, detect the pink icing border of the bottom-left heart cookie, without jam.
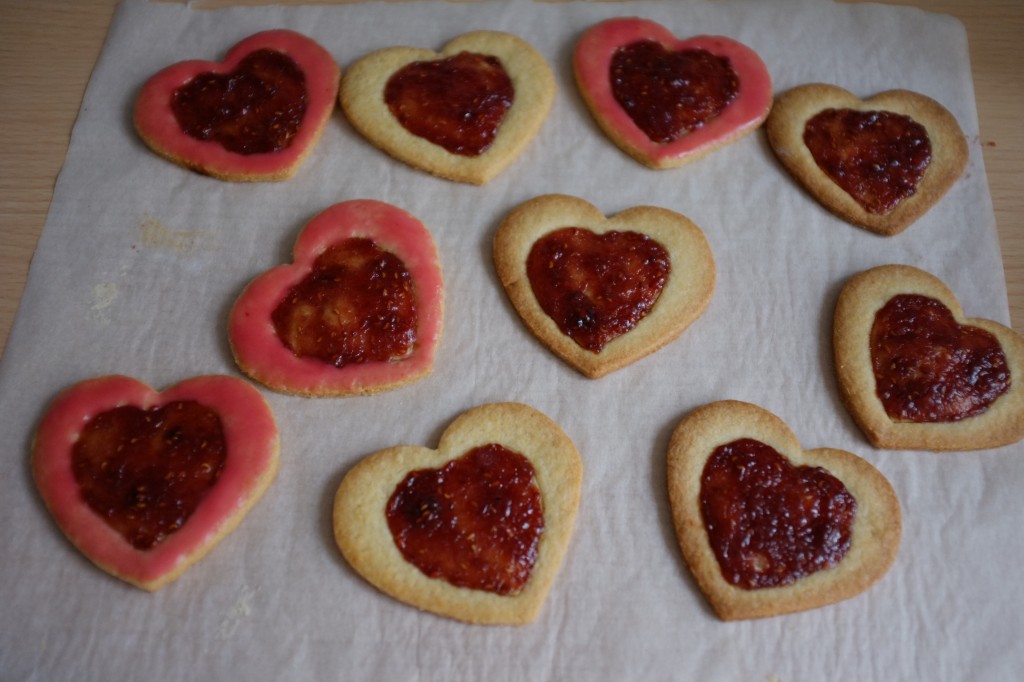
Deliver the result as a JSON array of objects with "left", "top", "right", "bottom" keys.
[{"left": 32, "top": 375, "right": 278, "bottom": 584}]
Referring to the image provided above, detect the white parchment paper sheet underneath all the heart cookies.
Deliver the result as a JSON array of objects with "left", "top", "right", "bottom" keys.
[{"left": 0, "top": 0, "right": 1024, "bottom": 682}]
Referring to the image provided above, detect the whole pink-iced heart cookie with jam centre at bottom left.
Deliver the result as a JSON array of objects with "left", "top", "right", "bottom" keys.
[{"left": 32, "top": 376, "right": 278, "bottom": 591}]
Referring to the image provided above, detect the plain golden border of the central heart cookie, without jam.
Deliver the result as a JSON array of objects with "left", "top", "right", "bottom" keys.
[{"left": 494, "top": 195, "right": 716, "bottom": 379}]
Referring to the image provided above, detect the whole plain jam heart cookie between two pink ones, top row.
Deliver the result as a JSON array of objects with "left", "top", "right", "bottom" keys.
[{"left": 340, "top": 31, "right": 555, "bottom": 184}]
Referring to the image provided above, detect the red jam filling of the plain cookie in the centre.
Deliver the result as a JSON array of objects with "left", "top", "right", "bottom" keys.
[{"left": 526, "top": 227, "right": 672, "bottom": 353}]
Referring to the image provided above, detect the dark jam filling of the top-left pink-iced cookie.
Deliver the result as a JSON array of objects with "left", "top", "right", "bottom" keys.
[{"left": 171, "top": 49, "right": 306, "bottom": 154}]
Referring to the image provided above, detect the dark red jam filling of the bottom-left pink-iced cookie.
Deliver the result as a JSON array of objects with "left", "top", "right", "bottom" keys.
[{"left": 72, "top": 400, "right": 227, "bottom": 550}]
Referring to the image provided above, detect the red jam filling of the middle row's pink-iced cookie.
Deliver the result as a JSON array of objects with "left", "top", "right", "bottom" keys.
[{"left": 270, "top": 238, "right": 418, "bottom": 368}]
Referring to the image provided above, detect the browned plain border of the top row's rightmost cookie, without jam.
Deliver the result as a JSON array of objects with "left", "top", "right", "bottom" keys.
[{"left": 765, "top": 83, "right": 968, "bottom": 237}]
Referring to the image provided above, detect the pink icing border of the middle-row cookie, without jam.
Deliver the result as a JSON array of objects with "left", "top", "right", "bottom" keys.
[{"left": 228, "top": 200, "right": 443, "bottom": 394}]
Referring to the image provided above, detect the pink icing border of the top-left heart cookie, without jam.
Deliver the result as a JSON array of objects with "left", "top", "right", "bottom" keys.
[{"left": 134, "top": 30, "right": 341, "bottom": 179}]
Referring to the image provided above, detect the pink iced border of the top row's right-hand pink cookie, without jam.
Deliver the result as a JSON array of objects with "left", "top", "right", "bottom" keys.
[{"left": 572, "top": 17, "right": 772, "bottom": 161}]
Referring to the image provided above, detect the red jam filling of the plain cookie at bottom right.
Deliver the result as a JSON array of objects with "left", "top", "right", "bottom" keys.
[{"left": 700, "top": 438, "right": 857, "bottom": 590}]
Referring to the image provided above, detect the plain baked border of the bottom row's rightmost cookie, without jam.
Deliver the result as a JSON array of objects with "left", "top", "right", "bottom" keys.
[{"left": 668, "top": 400, "right": 902, "bottom": 621}]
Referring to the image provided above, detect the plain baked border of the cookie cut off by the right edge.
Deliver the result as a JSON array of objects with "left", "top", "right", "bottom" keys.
[{"left": 833, "top": 265, "right": 1024, "bottom": 451}]
